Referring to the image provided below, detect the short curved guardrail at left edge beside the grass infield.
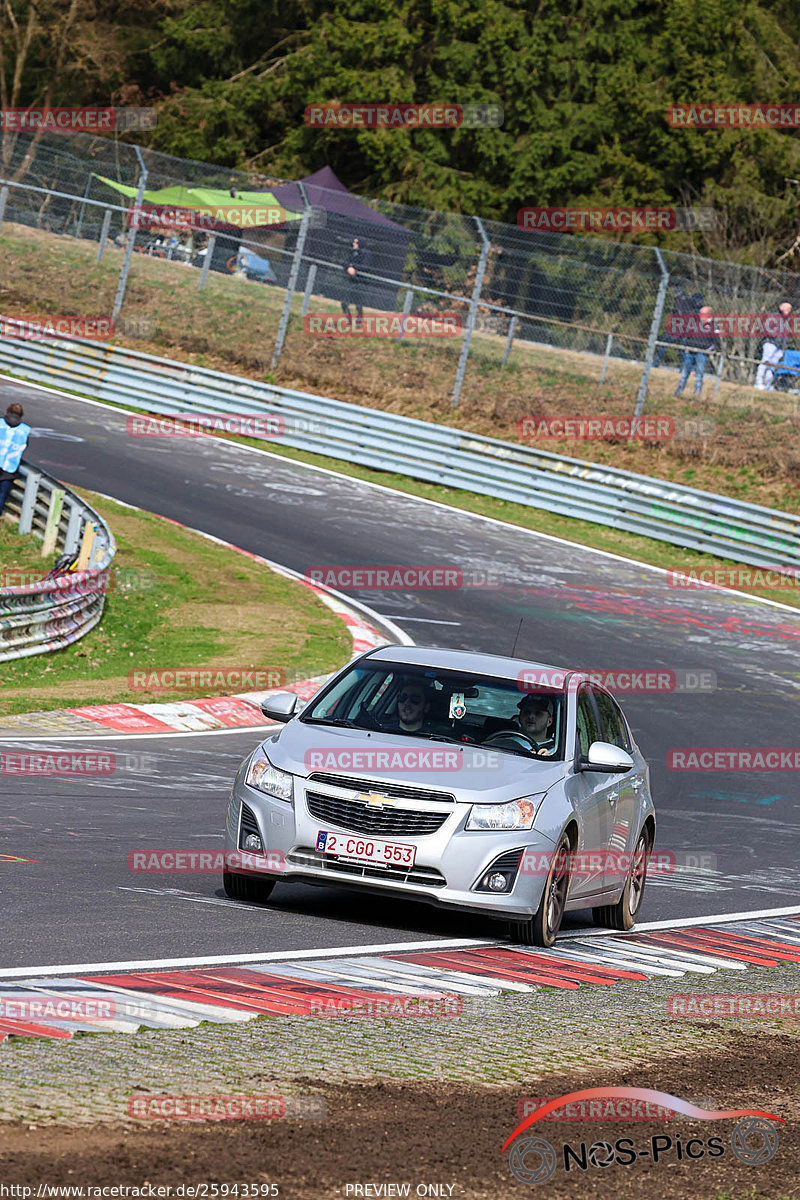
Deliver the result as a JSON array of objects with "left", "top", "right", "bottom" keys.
[{"left": 0, "top": 463, "right": 116, "bottom": 662}]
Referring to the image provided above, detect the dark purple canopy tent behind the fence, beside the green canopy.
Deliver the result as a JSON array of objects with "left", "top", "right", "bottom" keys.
[{"left": 270, "top": 167, "right": 411, "bottom": 310}]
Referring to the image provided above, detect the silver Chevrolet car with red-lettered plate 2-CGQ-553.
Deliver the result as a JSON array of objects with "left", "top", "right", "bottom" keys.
[{"left": 223, "top": 646, "right": 656, "bottom": 946}]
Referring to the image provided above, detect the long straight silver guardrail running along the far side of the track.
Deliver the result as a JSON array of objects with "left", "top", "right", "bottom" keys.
[{"left": 0, "top": 328, "right": 800, "bottom": 571}]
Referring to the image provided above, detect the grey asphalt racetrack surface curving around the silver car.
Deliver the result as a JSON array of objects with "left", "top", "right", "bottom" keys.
[{"left": 0, "top": 379, "right": 800, "bottom": 967}]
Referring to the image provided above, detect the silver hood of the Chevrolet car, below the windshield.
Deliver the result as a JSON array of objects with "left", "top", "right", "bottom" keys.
[{"left": 264, "top": 720, "right": 566, "bottom": 804}]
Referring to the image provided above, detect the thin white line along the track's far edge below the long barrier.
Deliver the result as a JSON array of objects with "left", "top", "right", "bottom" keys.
[{"left": 0, "top": 372, "right": 799, "bottom": 617}]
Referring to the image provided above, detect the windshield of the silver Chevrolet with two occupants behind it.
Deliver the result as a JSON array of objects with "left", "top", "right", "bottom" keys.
[{"left": 301, "top": 660, "right": 565, "bottom": 758}]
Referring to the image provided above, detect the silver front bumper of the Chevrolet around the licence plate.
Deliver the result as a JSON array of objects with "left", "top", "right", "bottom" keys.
[{"left": 225, "top": 774, "right": 554, "bottom": 920}]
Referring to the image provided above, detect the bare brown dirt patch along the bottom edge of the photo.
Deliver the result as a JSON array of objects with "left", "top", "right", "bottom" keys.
[{"left": 0, "top": 1032, "right": 800, "bottom": 1200}]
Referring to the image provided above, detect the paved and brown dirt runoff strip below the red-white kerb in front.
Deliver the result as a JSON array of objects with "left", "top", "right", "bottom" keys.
[{"left": 0, "top": 965, "right": 800, "bottom": 1200}]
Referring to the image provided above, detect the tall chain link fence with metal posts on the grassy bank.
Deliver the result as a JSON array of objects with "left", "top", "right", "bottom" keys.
[{"left": 0, "top": 133, "right": 800, "bottom": 413}]
